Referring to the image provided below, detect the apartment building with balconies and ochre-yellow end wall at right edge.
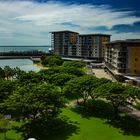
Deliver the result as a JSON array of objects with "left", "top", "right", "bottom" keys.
[{"left": 105, "top": 39, "right": 140, "bottom": 80}]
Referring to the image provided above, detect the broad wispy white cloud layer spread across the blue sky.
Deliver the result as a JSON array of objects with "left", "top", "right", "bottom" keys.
[{"left": 0, "top": 0, "right": 140, "bottom": 45}]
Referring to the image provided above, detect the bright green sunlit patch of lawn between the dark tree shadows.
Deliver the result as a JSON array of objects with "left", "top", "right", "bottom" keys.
[{"left": 63, "top": 109, "right": 140, "bottom": 140}]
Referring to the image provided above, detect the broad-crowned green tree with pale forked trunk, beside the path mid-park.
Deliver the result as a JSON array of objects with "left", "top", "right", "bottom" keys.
[{"left": 64, "top": 75, "right": 97, "bottom": 105}]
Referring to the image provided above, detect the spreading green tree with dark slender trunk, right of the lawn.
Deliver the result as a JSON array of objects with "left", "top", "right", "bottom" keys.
[{"left": 96, "top": 82, "right": 130, "bottom": 119}]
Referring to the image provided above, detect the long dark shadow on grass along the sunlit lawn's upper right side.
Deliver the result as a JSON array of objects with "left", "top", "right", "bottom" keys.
[{"left": 72, "top": 100, "right": 140, "bottom": 136}]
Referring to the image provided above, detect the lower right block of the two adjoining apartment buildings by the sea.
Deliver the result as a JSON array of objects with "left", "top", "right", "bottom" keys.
[{"left": 79, "top": 34, "right": 110, "bottom": 59}]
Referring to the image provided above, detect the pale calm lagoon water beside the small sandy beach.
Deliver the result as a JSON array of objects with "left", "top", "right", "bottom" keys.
[{"left": 0, "top": 59, "right": 40, "bottom": 72}]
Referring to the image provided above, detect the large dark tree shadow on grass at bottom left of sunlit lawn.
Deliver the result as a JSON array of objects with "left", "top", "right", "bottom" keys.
[{"left": 12, "top": 117, "right": 79, "bottom": 140}]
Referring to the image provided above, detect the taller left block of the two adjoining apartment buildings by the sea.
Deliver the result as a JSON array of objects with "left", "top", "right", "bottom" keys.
[{"left": 51, "top": 30, "right": 79, "bottom": 56}]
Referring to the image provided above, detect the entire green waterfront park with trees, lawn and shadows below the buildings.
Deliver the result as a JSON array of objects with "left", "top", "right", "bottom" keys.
[{"left": 0, "top": 55, "right": 140, "bottom": 140}]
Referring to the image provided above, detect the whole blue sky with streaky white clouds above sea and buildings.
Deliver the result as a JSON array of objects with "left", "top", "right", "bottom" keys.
[{"left": 0, "top": 0, "right": 140, "bottom": 46}]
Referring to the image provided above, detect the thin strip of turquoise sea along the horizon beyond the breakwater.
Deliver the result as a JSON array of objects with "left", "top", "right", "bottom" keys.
[{"left": 0, "top": 46, "right": 50, "bottom": 52}]
